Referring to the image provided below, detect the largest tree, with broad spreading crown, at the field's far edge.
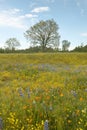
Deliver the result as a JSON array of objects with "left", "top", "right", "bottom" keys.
[{"left": 24, "top": 19, "right": 60, "bottom": 51}]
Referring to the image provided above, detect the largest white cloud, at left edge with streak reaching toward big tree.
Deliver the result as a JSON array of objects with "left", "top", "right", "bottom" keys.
[{"left": 0, "top": 8, "right": 38, "bottom": 29}]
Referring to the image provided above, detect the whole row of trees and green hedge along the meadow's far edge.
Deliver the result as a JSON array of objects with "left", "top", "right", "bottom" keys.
[{"left": 0, "top": 19, "right": 86, "bottom": 53}]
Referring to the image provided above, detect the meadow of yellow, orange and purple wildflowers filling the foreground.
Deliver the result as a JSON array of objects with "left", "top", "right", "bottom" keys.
[{"left": 0, "top": 53, "right": 87, "bottom": 130}]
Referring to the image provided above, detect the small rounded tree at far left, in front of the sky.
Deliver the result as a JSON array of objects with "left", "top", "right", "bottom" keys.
[{"left": 5, "top": 38, "right": 20, "bottom": 50}]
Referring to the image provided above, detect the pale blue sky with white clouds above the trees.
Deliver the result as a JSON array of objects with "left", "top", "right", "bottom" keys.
[{"left": 0, "top": 0, "right": 87, "bottom": 50}]
